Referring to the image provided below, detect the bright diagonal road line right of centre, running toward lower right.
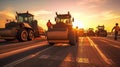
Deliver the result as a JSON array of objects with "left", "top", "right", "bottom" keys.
[{"left": 87, "top": 37, "right": 112, "bottom": 65}]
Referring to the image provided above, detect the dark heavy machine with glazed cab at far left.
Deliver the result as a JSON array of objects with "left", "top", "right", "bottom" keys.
[{"left": 0, "top": 11, "right": 40, "bottom": 41}]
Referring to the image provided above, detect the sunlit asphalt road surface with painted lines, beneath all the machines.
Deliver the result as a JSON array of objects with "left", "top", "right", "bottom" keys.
[{"left": 0, "top": 37, "right": 120, "bottom": 67}]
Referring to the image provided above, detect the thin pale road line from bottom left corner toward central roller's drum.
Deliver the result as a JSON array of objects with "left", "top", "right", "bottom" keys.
[{"left": 3, "top": 46, "right": 53, "bottom": 67}]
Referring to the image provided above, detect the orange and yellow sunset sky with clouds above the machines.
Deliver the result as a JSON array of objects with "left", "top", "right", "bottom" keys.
[{"left": 0, "top": 0, "right": 120, "bottom": 31}]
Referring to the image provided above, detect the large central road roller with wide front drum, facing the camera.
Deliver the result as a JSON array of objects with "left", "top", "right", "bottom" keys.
[{"left": 47, "top": 12, "right": 78, "bottom": 45}]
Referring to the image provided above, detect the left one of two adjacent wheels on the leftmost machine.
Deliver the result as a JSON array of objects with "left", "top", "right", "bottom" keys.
[{"left": 17, "top": 29, "right": 28, "bottom": 42}]
